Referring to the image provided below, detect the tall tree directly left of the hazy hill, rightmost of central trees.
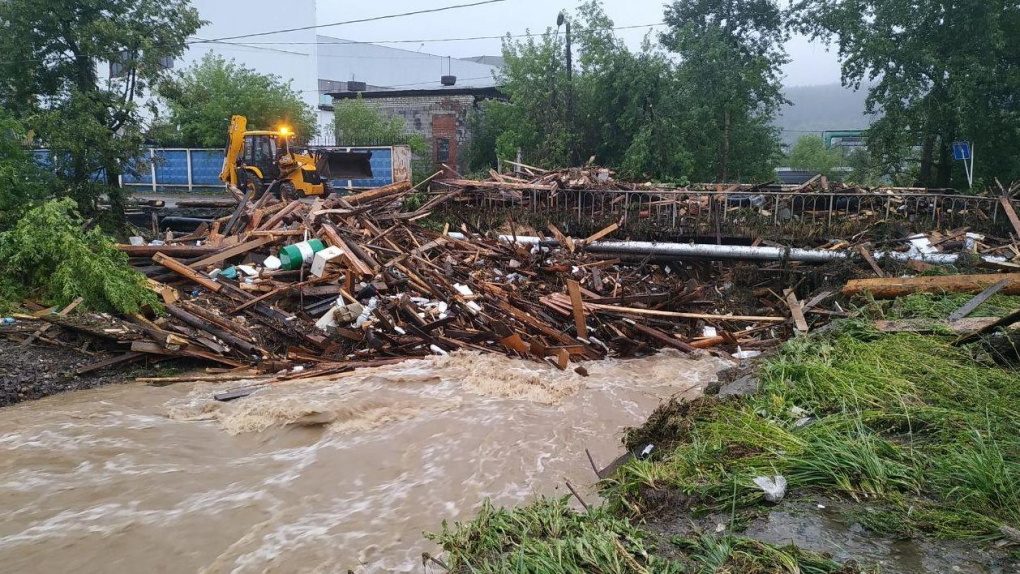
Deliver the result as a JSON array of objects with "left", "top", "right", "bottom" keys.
[{"left": 662, "top": 0, "right": 788, "bottom": 180}]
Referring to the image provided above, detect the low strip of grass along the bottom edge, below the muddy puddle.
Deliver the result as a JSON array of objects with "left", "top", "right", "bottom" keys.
[{"left": 426, "top": 498, "right": 862, "bottom": 574}]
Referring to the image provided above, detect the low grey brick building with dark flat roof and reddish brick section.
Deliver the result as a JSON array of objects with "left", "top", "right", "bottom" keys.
[{"left": 329, "top": 88, "right": 506, "bottom": 177}]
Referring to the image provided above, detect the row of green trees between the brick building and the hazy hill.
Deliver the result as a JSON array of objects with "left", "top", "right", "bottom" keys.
[{"left": 470, "top": 0, "right": 784, "bottom": 180}]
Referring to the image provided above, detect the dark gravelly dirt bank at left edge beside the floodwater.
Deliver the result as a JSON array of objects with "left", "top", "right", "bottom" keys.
[{"left": 0, "top": 338, "right": 122, "bottom": 407}]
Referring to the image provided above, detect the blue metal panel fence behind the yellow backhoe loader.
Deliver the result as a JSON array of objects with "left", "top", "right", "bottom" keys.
[{"left": 33, "top": 147, "right": 397, "bottom": 192}]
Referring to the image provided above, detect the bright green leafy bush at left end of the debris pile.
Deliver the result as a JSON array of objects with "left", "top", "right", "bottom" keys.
[{"left": 0, "top": 199, "right": 159, "bottom": 313}]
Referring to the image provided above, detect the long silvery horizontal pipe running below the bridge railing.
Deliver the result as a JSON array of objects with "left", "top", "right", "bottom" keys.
[{"left": 450, "top": 233, "right": 1008, "bottom": 265}]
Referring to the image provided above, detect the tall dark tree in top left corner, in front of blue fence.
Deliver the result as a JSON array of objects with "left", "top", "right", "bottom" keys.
[{"left": 0, "top": 0, "right": 202, "bottom": 218}]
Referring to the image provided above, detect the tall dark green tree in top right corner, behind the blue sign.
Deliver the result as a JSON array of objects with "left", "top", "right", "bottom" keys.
[{"left": 793, "top": 0, "right": 1020, "bottom": 188}]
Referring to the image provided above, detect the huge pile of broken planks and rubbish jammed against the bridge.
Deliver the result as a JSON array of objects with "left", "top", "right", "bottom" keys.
[{"left": 0, "top": 175, "right": 1020, "bottom": 393}]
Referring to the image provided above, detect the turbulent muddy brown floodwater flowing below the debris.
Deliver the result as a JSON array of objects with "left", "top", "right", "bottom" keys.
[{"left": 0, "top": 353, "right": 727, "bottom": 574}]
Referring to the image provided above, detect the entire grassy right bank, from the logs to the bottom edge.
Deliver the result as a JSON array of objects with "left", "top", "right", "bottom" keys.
[{"left": 434, "top": 296, "right": 1020, "bottom": 573}]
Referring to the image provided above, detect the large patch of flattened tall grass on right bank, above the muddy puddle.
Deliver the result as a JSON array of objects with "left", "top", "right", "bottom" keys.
[{"left": 605, "top": 323, "right": 1020, "bottom": 540}]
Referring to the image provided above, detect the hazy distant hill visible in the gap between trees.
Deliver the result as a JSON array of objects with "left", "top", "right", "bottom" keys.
[{"left": 775, "top": 84, "right": 874, "bottom": 145}]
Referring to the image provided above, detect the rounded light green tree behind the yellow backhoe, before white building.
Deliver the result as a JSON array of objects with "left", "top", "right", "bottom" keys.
[{"left": 156, "top": 52, "right": 318, "bottom": 148}]
